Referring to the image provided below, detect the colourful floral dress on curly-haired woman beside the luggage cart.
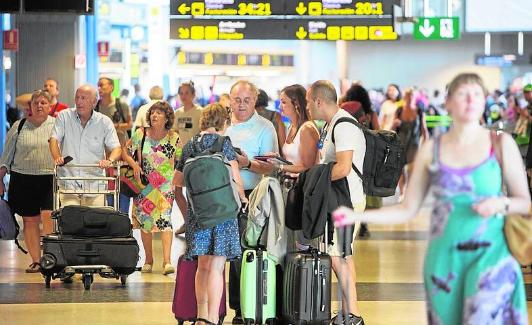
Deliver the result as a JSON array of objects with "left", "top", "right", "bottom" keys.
[{"left": 131, "top": 129, "right": 178, "bottom": 232}]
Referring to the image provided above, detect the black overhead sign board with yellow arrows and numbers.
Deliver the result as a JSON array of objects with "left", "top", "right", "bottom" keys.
[{"left": 170, "top": 0, "right": 398, "bottom": 41}]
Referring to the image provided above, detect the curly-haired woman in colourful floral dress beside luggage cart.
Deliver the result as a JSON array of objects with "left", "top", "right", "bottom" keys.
[{"left": 123, "top": 101, "right": 178, "bottom": 274}]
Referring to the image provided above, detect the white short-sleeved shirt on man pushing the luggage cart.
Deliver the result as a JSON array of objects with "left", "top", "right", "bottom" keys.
[{"left": 51, "top": 108, "right": 120, "bottom": 189}]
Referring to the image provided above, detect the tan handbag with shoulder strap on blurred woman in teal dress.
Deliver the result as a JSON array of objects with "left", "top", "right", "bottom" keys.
[{"left": 491, "top": 132, "right": 532, "bottom": 265}]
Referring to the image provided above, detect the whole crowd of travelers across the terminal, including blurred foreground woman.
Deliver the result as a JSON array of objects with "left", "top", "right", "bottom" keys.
[{"left": 0, "top": 74, "right": 532, "bottom": 325}]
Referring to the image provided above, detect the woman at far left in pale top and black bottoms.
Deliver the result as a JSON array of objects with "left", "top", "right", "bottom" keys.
[{"left": 0, "top": 90, "right": 55, "bottom": 273}]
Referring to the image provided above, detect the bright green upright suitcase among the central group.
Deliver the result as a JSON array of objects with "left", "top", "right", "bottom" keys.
[{"left": 240, "top": 248, "right": 276, "bottom": 324}]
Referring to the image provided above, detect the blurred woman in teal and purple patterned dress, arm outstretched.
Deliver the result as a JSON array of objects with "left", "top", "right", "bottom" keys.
[{"left": 334, "top": 74, "right": 530, "bottom": 325}]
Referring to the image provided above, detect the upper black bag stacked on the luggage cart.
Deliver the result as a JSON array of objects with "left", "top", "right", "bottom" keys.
[{"left": 52, "top": 205, "right": 132, "bottom": 238}]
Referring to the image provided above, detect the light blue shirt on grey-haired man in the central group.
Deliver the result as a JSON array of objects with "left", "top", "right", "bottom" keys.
[{"left": 225, "top": 112, "right": 279, "bottom": 190}]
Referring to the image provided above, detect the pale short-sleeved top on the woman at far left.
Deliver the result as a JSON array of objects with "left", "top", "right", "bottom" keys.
[{"left": 0, "top": 116, "right": 55, "bottom": 175}]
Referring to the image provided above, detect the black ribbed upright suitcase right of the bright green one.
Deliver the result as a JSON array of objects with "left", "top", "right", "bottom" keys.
[{"left": 283, "top": 249, "right": 332, "bottom": 325}]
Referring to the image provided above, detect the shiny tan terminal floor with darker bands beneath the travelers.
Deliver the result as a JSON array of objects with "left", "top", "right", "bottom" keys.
[{"left": 0, "top": 199, "right": 532, "bottom": 325}]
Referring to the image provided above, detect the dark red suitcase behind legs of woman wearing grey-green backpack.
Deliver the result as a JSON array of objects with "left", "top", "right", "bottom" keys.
[{"left": 172, "top": 256, "right": 227, "bottom": 325}]
